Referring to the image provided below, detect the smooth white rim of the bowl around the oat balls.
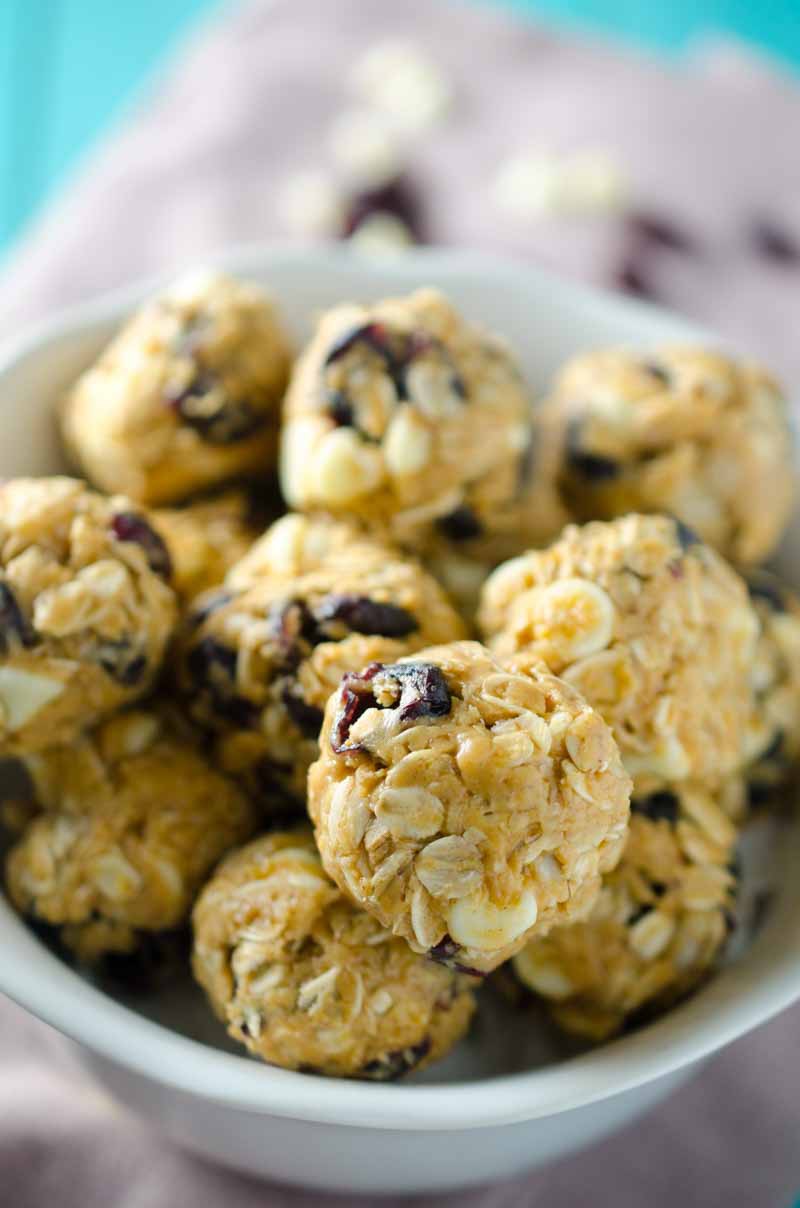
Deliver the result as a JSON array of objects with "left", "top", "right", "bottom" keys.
[{"left": 0, "top": 244, "right": 800, "bottom": 1132}]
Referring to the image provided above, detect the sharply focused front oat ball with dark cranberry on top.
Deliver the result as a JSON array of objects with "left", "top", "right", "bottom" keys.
[{"left": 308, "top": 641, "right": 631, "bottom": 972}]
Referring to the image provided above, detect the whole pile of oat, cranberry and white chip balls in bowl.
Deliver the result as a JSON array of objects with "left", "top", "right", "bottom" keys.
[{"left": 0, "top": 274, "right": 800, "bottom": 1079}]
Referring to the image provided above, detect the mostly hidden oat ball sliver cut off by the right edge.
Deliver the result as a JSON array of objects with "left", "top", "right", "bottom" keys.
[{"left": 747, "top": 570, "right": 800, "bottom": 803}]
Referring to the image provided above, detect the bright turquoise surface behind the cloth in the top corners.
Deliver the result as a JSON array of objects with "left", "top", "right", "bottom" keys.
[{"left": 0, "top": 0, "right": 800, "bottom": 257}]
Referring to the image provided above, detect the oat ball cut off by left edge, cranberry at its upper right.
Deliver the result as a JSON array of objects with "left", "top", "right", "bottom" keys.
[{"left": 0, "top": 478, "right": 176, "bottom": 755}]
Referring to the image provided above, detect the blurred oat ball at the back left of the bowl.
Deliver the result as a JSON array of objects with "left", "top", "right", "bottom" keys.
[{"left": 60, "top": 273, "right": 290, "bottom": 504}]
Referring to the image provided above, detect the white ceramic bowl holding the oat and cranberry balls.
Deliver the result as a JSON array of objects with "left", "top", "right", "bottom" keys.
[{"left": 0, "top": 249, "right": 800, "bottom": 1191}]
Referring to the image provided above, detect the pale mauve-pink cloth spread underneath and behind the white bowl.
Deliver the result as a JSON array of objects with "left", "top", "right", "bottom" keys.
[{"left": 0, "top": 0, "right": 800, "bottom": 1208}]
